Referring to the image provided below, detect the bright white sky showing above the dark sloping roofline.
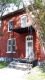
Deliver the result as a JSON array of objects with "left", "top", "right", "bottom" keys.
[{"left": 0, "top": 0, "right": 33, "bottom": 16}]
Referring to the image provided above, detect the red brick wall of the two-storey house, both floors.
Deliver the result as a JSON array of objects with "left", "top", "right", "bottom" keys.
[{"left": 0, "top": 11, "right": 45, "bottom": 61}]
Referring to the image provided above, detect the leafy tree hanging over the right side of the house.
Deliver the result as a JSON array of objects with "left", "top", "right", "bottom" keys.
[{"left": 25, "top": 0, "right": 45, "bottom": 45}]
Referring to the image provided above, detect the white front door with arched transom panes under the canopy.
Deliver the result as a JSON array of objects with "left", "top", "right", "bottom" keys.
[{"left": 26, "top": 35, "right": 34, "bottom": 58}]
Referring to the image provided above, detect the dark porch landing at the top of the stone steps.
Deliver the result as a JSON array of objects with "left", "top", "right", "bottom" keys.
[{"left": 13, "top": 58, "right": 38, "bottom": 66}]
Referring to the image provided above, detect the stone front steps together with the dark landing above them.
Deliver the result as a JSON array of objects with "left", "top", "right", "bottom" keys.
[{"left": 8, "top": 58, "right": 37, "bottom": 70}]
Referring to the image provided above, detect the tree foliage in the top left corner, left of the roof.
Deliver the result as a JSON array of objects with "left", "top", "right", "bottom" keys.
[{"left": 0, "top": 0, "right": 22, "bottom": 36}]
